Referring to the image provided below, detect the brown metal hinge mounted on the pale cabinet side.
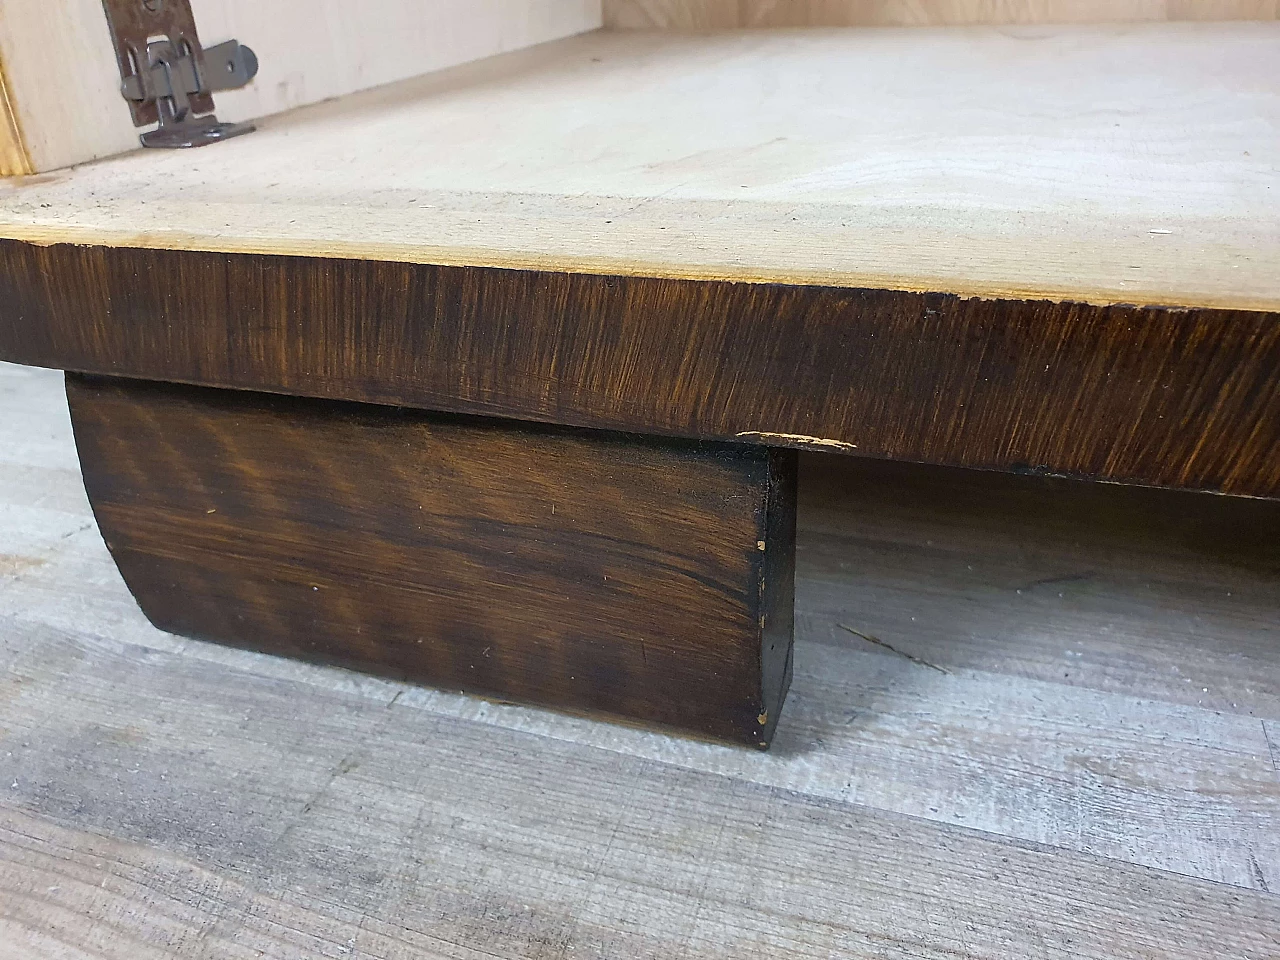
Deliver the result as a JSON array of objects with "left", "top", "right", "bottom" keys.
[{"left": 102, "top": 0, "right": 257, "bottom": 147}]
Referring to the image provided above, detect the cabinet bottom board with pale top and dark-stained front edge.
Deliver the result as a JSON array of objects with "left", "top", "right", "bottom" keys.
[{"left": 0, "top": 23, "right": 1280, "bottom": 742}]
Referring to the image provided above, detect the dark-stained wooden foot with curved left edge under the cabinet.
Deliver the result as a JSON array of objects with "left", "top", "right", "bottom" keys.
[{"left": 67, "top": 374, "right": 796, "bottom": 746}]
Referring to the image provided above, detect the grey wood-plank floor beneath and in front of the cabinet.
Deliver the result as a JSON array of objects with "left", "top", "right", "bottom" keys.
[{"left": 0, "top": 365, "right": 1280, "bottom": 960}]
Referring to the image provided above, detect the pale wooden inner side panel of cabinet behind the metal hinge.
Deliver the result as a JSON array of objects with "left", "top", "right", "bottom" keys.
[{"left": 0, "top": 0, "right": 600, "bottom": 174}]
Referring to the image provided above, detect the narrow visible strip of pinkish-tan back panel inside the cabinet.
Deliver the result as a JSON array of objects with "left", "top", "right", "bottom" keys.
[{"left": 604, "top": 0, "right": 1280, "bottom": 29}]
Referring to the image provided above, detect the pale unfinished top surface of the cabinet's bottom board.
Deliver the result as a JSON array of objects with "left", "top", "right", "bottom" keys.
[{"left": 0, "top": 26, "right": 1280, "bottom": 312}]
